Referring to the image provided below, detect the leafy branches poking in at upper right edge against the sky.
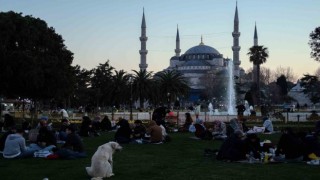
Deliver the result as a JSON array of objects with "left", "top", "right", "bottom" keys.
[{"left": 309, "top": 27, "right": 320, "bottom": 62}]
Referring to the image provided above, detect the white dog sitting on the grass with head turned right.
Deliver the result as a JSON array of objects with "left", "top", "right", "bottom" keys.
[{"left": 86, "top": 142, "right": 122, "bottom": 180}]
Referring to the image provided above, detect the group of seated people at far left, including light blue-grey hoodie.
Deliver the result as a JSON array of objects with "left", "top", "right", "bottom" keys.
[{"left": 0, "top": 116, "right": 86, "bottom": 159}]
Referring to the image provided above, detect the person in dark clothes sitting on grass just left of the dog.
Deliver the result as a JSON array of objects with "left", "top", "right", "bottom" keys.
[{"left": 55, "top": 125, "right": 87, "bottom": 159}]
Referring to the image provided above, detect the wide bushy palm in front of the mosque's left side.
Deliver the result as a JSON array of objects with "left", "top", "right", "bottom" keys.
[{"left": 155, "top": 70, "right": 190, "bottom": 105}]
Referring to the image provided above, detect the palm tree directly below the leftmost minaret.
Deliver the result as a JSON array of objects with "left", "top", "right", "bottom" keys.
[{"left": 133, "top": 69, "right": 152, "bottom": 108}]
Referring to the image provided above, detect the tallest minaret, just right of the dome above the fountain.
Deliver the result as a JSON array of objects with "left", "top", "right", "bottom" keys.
[{"left": 232, "top": 3, "right": 241, "bottom": 77}]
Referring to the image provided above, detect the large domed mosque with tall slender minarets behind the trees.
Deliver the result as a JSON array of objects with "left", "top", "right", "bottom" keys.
[{"left": 139, "top": 5, "right": 257, "bottom": 101}]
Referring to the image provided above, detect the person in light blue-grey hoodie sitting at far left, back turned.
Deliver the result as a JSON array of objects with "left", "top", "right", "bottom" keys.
[{"left": 3, "top": 129, "right": 36, "bottom": 159}]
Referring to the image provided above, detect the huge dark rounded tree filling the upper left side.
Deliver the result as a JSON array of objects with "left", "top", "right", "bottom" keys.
[{"left": 0, "top": 11, "right": 75, "bottom": 105}]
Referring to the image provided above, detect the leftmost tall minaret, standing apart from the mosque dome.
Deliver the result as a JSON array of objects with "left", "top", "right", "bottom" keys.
[{"left": 139, "top": 9, "right": 148, "bottom": 70}]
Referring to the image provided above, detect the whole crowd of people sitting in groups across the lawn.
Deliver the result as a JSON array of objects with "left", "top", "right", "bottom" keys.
[{"left": 0, "top": 109, "right": 320, "bottom": 164}]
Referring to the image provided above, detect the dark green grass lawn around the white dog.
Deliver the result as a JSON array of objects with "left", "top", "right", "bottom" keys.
[{"left": 0, "top": 133, "right": 320, "bottom": 180}]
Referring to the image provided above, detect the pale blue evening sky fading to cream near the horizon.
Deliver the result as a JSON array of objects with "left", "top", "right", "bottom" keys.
[{"left": 0, "top": 0, "right": 320, "bottom": 78}]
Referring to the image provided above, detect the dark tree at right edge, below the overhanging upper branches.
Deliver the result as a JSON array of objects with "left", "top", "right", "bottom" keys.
[{"left": 300, "top": 74, "right": 320, "bottom": 104}]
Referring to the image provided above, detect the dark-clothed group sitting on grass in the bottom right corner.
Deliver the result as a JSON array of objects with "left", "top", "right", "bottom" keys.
[{"left": 216, "top": 128, "right": 320, "bottom": 165}]
